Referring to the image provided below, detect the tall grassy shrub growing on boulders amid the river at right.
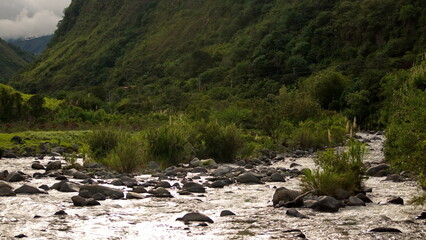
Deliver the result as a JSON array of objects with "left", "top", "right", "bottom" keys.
[{"left": 302, "top": 140, "right": 365, "bottom": 196}]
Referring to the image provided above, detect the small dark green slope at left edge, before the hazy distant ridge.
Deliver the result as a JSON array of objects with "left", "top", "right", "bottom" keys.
[{"left": 0, "top": 39, "right": 34, "bottom": 82}]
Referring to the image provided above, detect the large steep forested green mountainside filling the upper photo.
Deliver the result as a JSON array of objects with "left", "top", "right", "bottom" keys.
[{"left": 10, "top": 0, "right": 426, "bottom": 125}]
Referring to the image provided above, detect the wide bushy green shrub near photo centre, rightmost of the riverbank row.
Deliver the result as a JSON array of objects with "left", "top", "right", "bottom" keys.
[{"left": 193, "top": 122, "right": 243, "bottom": 162}]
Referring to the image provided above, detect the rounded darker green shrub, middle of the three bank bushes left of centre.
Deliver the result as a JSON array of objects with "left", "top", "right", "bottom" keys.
[{"left": 145, "top": 126, "right": 190, "bottom": 167}]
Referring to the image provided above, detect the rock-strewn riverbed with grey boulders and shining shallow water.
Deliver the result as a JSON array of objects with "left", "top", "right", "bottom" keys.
[{"left": 0, "top": 133, "right": 426, "bottom": 240}]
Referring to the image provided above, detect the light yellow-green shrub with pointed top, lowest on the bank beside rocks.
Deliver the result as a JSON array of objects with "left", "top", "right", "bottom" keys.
[{"left": 105, "top": 133, "right": 144, "bottom": 173}]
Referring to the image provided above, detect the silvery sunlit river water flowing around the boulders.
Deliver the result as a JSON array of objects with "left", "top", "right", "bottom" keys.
[{"left": 0, "top": 134, "right": 426, "bottom": 240}]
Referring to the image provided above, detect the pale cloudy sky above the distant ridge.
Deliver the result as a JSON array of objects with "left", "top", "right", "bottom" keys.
[{"left": 0, "top": 0, "right": 71, "bottom": 39}]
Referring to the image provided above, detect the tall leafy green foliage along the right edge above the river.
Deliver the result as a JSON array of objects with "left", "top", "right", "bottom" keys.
[{"left": 384, "top": 62, "right": 426, "bottom": 178}]
